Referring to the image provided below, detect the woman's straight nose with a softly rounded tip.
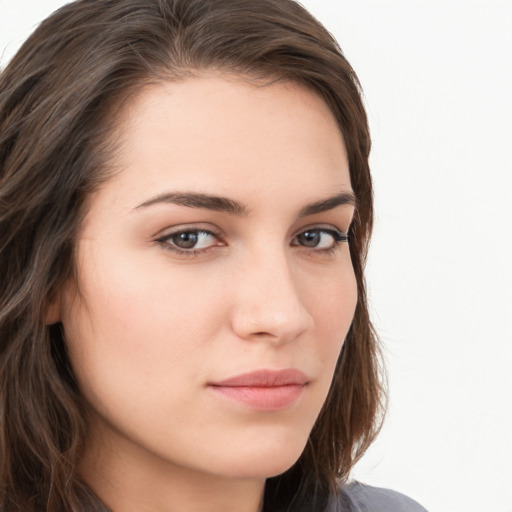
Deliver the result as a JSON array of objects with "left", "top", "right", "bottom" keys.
[{"left": 231, "top": 247, "right": 314, "bottom": 344}]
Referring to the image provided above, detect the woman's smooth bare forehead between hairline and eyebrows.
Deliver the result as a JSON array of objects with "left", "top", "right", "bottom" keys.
[{"left": 92, "top": 76, "right": 350, "bottom": 212}]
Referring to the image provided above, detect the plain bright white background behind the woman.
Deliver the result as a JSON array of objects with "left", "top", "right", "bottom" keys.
[{"left": 0, "top": 0, "right": 512, "bottom": 512}]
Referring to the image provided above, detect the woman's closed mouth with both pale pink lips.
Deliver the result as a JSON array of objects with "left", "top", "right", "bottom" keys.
[{"left": 208, "top": 369, "right": 309, "bottom": 411}]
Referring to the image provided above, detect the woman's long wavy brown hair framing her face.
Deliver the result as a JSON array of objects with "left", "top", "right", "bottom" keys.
[{"left": 0, "top": 0, "right": 384, "bottom": 512}]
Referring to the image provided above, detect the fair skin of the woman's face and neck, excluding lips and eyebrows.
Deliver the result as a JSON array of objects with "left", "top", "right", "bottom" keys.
[{"left": 51, "top": 74, "right": 357, "bottom": 512}]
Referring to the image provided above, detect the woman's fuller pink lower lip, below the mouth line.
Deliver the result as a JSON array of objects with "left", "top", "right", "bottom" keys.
[{"left": 210, "top": 384, "right": 304, "bottom": 411}]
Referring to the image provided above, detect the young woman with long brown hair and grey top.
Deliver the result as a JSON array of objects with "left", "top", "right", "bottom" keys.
[{"left": 0, "top": 0, "right": 423, "bottom": 512}]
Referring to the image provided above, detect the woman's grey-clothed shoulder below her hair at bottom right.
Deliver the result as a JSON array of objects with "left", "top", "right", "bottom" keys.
[{"left": 329, "top": 482, "right": 427, "bottom": 512}]
